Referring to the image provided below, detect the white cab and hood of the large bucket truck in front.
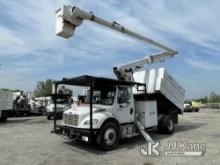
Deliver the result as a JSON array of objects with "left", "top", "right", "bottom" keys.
[{"left": 63, "top": 86, "right": 135, "bottom": 129}]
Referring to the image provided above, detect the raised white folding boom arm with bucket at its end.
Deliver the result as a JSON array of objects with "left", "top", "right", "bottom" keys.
[{"left": 56, "top": 5, "right": 177, "bottom": 81}]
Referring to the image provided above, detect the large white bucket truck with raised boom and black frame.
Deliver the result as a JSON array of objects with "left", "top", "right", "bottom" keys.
[{"left": 53, "top": 5, "right": 185, "bottom": 150}]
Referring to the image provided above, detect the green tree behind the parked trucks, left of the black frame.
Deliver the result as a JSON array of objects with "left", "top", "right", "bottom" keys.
[{"left": 34, "top": 79, "right": 53, "bottom": 97}]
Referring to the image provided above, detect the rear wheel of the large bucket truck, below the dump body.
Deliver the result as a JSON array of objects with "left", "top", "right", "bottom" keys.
[{"left": 158, "top": 115, "right": 174, "bottom": 134}]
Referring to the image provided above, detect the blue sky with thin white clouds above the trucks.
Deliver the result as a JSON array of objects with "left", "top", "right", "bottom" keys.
[{"left": 0, "top": 0, "right": 220, "bottom": 98}]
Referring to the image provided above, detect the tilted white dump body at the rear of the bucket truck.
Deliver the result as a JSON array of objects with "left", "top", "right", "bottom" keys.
[{"left": 133, "top": 68, "right": 185, "bottom": 113}]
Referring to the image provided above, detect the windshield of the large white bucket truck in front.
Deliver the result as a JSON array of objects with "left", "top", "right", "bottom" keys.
[{"left": 85, "top": 88, "right": 115, "bottom": 105}]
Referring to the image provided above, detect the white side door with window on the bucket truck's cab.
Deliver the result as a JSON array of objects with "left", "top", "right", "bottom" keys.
[{"left": 116, "top": 86, "right": 135, "bottom": 123}]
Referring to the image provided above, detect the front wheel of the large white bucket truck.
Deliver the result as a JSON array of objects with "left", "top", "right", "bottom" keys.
[{"left": 97, "top": 121, "right": 120, "bottom": 151}]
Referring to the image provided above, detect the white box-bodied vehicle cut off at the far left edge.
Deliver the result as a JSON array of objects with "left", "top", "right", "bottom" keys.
[{"left": 0, "top": 91, "right": 13, "bottom": 122}]
